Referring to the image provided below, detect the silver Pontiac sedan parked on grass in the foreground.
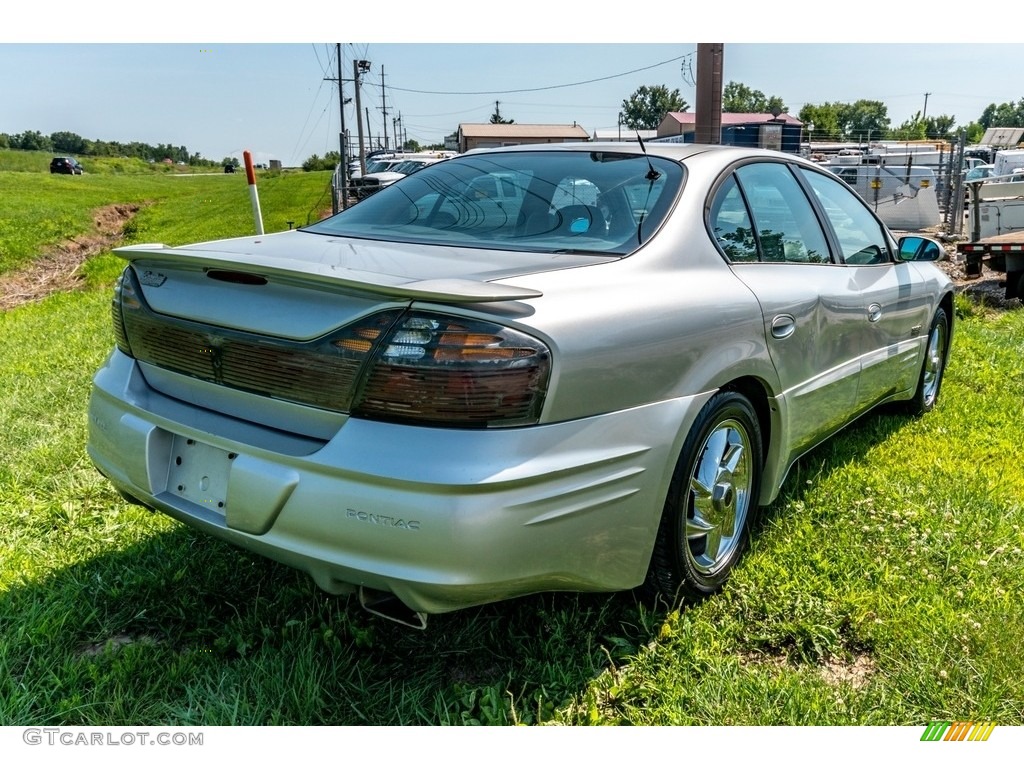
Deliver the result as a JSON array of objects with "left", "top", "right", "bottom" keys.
[{"left": 88, "top": 143, "right": 953, "bottom": 627}]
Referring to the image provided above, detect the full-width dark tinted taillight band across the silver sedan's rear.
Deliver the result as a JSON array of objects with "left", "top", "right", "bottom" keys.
[{"left": 112, "top": 267, "right": 551, "bottom": 428}]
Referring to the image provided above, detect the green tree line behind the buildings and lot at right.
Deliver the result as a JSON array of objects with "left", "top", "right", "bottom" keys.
[{"left": 620, "top": 82, "right": 1024, "bottom": 143}]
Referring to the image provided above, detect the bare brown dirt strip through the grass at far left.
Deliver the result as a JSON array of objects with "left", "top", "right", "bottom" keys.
[{"left": 0, "top": 205, "right": 141, "bottom": 311}]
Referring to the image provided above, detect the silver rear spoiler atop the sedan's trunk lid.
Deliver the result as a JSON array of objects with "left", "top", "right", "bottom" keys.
[{"left": 114, "top": 243, "right": 544, "bottom": 303}]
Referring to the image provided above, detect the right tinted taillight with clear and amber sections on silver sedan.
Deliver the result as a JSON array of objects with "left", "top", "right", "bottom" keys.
[{"left": 352, "top": 313, "right": 551, "bottom": 427}]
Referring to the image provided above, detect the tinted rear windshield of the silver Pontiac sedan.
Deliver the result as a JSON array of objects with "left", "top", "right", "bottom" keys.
[{"left": 305, "top": 151, "right": 683, "bottom": 255}]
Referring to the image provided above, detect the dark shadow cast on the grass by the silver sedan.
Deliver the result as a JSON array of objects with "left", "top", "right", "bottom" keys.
[{"left": 0, "top": 411, "right": 907, "bottom": 725}]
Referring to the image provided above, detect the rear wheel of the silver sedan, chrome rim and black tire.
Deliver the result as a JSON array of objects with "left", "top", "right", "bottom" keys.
[{"left": 643, "top": 391, "right": 763, "bottom": 605}]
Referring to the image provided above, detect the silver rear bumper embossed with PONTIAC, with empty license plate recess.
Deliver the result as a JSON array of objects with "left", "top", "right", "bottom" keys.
[{"left": 88, "top": 351, "right": 702, "bottom": 613}]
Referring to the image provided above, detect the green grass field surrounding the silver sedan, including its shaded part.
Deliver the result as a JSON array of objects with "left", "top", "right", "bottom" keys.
[{"left": 0, "top": 160, "right": 1024, "bottom": 726}]
